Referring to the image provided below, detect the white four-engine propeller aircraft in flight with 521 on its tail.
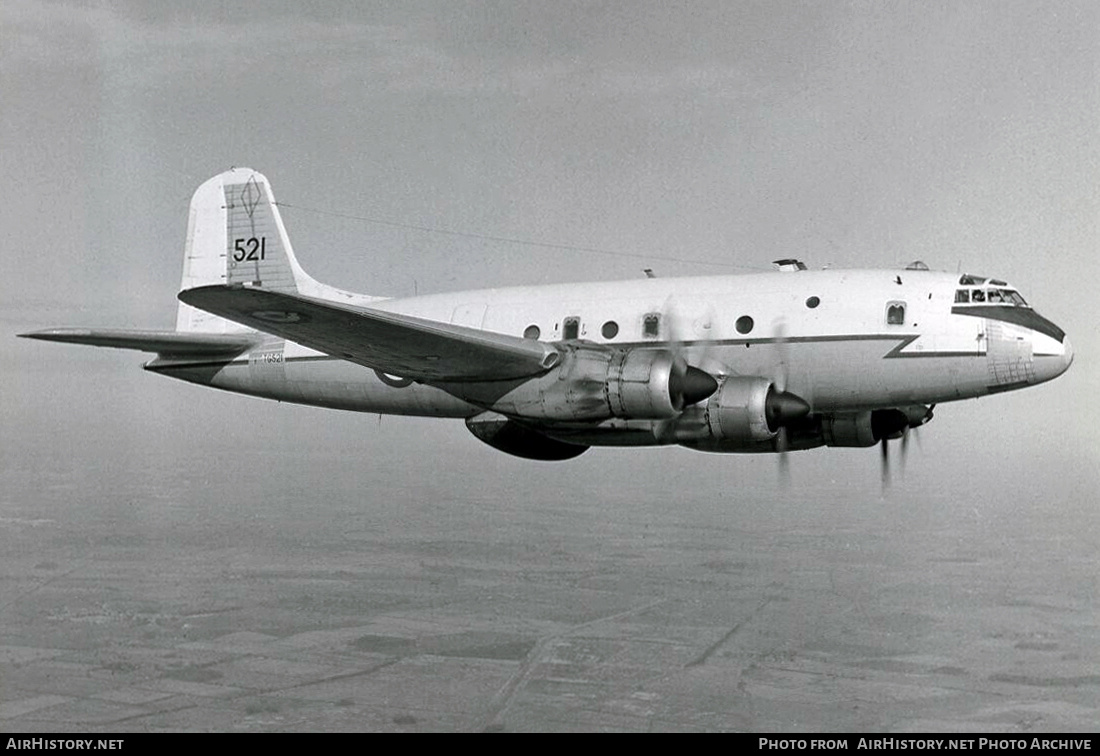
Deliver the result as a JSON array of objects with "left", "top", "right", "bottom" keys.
[{"left": 22, "top": 168, "right": 1073, "bottom": 460}]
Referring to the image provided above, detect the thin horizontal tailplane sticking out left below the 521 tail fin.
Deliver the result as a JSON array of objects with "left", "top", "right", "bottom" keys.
[{"left": 19, "top": 328, "right": 260, "bottom": 357}]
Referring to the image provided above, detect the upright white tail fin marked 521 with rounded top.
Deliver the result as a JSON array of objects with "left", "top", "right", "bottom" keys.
[{"left": 176, "top": 168, "right": 329, "bottom": 333}]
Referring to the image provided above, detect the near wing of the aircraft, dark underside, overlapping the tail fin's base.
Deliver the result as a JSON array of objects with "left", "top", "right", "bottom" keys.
[{"left": 179, "top": 284, "right": 559, "bottom": 383}]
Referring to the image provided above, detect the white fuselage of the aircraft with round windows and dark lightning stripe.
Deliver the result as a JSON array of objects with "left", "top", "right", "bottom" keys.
[{"left": 147, "top": 270, "right": 1073, "bottom": 431}]
